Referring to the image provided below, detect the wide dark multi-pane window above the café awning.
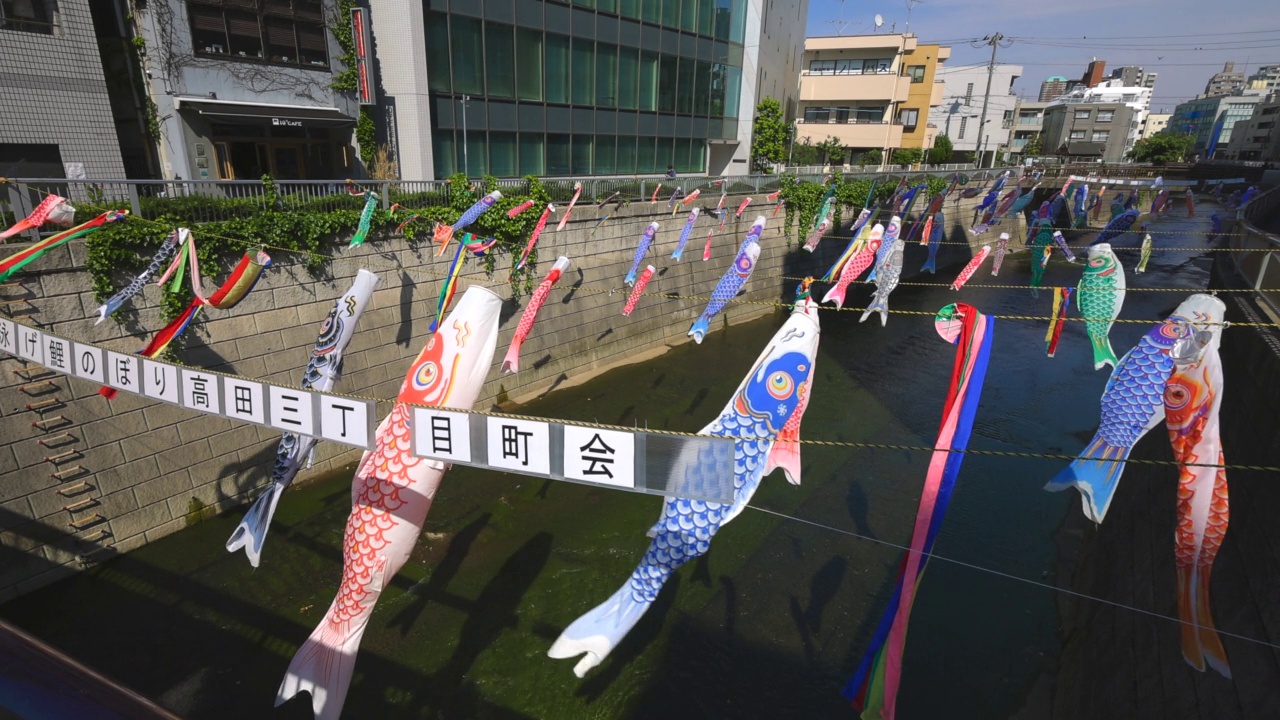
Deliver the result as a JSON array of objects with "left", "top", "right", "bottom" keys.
[{"left": 190, "top": 0, "right": 329, "bottom": 70}]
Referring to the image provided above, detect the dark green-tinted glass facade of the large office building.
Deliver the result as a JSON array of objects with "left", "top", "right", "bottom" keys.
[{"left": 425, "top": 0, "right": 750, "bottom": 178}]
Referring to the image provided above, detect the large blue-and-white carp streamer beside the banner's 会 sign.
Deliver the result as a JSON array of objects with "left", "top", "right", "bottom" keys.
[{"left": 547, "top": 288, "right": 818, "bottom": 678}]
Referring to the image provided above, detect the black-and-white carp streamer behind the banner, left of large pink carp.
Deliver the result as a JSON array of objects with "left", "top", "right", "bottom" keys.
[{"left": 227, "top": 269, "right": 378, "bottom": 568}]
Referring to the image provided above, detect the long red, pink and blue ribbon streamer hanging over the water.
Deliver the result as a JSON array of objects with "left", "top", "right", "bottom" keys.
[{"left": 844, "top": 302, "right": 995, "bottom": 720}]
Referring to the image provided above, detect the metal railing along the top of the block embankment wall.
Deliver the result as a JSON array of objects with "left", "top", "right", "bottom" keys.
[{"left": 0, "top": 164, "right": 1004, "bottom": 242}]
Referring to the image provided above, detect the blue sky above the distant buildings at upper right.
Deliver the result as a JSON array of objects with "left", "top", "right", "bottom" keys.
[{"left": 806, "top": 0, "right": 1280, "bottom": 111}]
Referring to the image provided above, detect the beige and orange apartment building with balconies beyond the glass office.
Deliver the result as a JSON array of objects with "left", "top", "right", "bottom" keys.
[{"left": 796, "top": 35, "right": 951, "bottom": 161}]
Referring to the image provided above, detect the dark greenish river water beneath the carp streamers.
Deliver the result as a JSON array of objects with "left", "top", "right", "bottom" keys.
[{"left": 0, "top": 203, "right": 1210, "bottom": 719}]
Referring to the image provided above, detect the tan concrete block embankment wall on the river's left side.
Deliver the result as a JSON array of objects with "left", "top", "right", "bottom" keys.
[{"left": 0, "top": 188, "right": 995, "bottom": 601}]
